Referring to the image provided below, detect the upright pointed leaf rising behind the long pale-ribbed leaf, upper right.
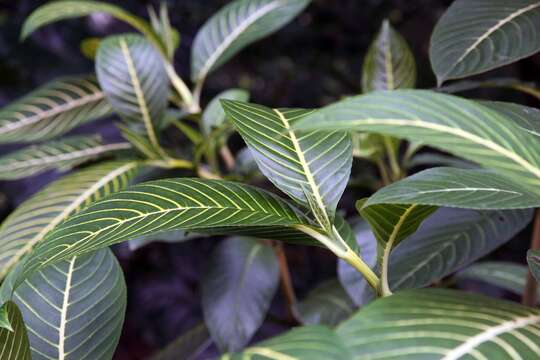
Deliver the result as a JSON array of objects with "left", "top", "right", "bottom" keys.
[{"left": 362, "top": 20, "right": 416, "bottom": 93}]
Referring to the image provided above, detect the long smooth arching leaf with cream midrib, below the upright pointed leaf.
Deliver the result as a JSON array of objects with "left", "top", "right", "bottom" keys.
[{"left": 296, "top": 90, "right": 540, "bottom": 193}]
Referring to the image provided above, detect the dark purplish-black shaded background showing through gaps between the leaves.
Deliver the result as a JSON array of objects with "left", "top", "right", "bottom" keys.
[{"left": 0, "top": 0, "right": 539, "bottom": 360}]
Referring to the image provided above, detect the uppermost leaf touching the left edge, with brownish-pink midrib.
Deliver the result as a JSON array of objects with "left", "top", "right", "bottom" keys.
[{"left": 0, "top": 75, "right": 111, "bottom": 143}]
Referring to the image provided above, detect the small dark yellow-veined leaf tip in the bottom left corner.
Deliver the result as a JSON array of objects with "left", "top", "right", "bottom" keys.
[{"left": 0, "top": 301, "right": 31, "bottom": 360}]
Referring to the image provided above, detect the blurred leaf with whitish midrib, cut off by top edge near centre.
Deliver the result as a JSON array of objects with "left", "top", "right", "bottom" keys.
[{"left": 191, "top": 0, "right": 310, "bottom": 83}]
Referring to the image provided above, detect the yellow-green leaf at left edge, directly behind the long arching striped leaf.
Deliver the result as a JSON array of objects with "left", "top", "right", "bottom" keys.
[{"left": 0, "top": 161, "right": 138, "bottom": 279}]
